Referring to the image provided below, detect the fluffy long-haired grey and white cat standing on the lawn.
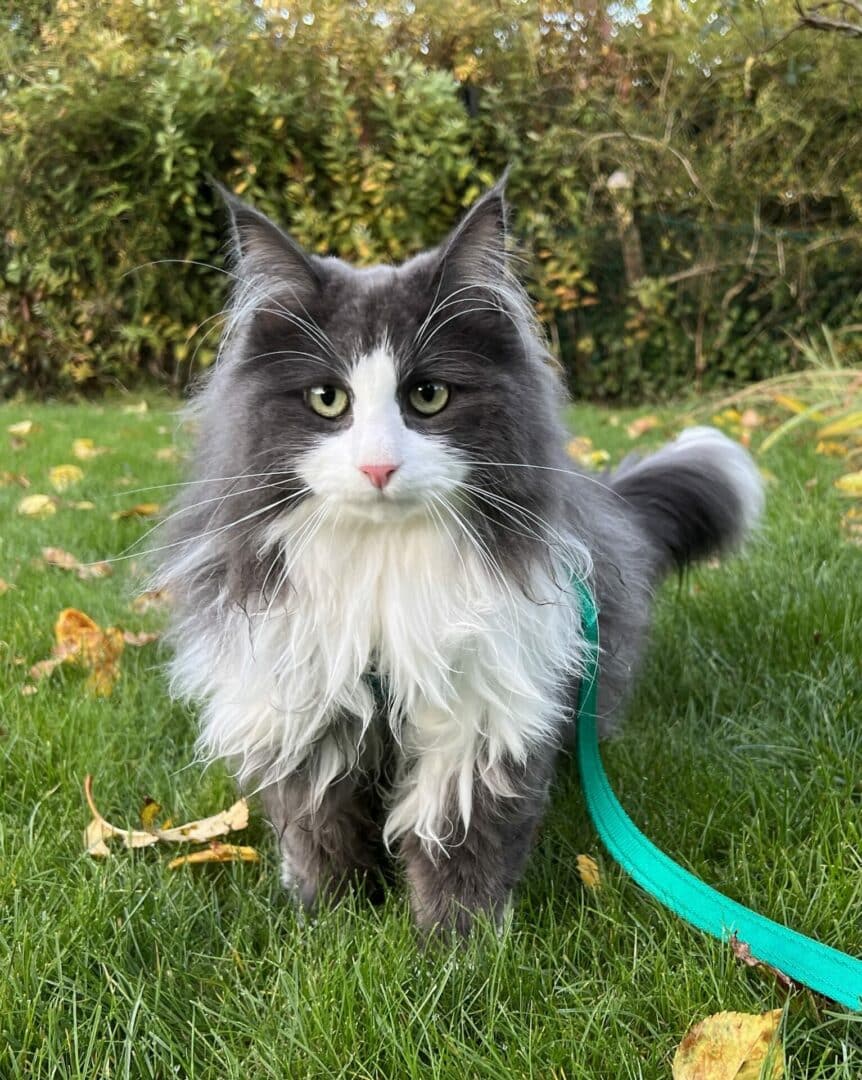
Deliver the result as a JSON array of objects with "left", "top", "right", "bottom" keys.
[{"left": 160, "top": 185, "right": 763, "bottom": 932}]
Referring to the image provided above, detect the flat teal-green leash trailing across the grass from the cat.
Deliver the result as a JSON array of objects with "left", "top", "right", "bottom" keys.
[{"left": 573, "top": 581, "right": 862, "bottom": 1011}]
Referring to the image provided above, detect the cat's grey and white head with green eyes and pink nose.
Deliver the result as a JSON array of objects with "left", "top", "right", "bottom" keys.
[{"left": 167, "top": 184, "right": 558, "bottom": 596}]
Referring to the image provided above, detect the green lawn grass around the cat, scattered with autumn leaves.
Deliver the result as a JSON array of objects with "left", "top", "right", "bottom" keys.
[{"left": 0, "top": 400, "right": 862, "bottom": 1080}]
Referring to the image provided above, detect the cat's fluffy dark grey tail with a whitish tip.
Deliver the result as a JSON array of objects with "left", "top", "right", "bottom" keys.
[{"left": 610, "top": 428, "right": 764, "bottom": 571}]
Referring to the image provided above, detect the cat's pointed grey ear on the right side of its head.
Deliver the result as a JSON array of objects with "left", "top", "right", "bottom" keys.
[{"left": 439, "top": 168, "right": 509, "bottom": 287}]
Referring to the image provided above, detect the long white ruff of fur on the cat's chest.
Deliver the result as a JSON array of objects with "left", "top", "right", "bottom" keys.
[{"left": 173, "top": 498, "right": 589, "bottom": 851}]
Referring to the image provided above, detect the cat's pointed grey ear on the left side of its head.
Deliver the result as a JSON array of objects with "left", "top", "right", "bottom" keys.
[{"left": 215, "top": 184, "right": 321, "bottom": 300}]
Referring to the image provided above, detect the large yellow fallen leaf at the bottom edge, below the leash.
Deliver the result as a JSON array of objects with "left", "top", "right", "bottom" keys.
[{"left": 673, "top": 1009, "right": 784, "bottom": 1080}]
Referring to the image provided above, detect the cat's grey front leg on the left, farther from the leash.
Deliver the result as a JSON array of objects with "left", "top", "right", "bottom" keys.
[{"left": 262, "top": 772, "right": 383, "bottom": 909}]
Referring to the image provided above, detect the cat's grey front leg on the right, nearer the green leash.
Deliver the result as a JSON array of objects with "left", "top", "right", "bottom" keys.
[{"left": 400, "top": 747, "right": 554, "bottom": 935}]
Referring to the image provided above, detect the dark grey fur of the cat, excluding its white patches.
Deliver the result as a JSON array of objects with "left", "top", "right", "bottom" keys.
[{"left": 160, "top": 186, "right": 758, "bottom": 932}]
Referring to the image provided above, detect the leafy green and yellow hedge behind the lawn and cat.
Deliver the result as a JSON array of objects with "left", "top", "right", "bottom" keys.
[{"left": 0, "top": 0, "right": 862, "bottom": 400}]
